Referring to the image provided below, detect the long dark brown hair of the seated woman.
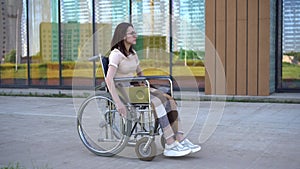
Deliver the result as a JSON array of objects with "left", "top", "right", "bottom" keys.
[{"left": 110, "top": 22, "right": 134, "bottom": 56}]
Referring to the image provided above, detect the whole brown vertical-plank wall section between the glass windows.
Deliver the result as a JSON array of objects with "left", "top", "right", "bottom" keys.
[{"left": 205, "top": 0, "right": 270, "bottom": 95}]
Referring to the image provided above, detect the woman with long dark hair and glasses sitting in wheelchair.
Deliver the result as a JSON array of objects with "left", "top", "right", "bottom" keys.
[{"left": 106, "top": 22, "right": 201, "bottom": 157}]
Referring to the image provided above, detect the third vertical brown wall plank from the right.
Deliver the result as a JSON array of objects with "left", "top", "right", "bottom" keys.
[{"left": 237, "top": 0, "right": 247, "bottom": 95}]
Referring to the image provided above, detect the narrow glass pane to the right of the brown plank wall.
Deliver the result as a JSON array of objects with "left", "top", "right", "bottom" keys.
[{"left": 281, "top": 0, "right": 300, "bottom": 89}]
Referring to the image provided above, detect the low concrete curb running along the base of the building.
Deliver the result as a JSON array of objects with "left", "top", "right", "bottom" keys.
[{"left": 0, "top": 88, "right": 300, "bottom": 104}]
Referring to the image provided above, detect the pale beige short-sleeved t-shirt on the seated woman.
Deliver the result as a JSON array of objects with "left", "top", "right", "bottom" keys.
[{"left": 109, "top": 49, "right": 140, "bottom": 77}]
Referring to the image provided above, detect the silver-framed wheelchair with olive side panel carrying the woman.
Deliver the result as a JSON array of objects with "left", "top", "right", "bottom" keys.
[{"left": 77, "top": 55, "right": 173, "bottom": 161}]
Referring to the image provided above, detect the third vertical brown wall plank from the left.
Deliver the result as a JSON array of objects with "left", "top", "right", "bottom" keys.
[{"left": 226, "top": 0, "right": 237, "bottom": 95}]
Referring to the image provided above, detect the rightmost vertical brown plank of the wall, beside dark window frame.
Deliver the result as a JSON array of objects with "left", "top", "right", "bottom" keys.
[{"left": 258, "top": 0, "right": 270, "bottom": 96}]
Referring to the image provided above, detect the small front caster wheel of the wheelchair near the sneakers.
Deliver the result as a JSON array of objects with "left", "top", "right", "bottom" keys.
[{"left": 135, "top": 137, "right": 156, "bottom": 161}]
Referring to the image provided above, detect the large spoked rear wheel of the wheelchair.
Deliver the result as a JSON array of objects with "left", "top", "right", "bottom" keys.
[{"left": 77, "top": 96, "right": 131, "bottom": 156}]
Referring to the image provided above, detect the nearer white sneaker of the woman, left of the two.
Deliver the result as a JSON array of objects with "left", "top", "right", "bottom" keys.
[{"left": 164, "top": 141, "right": 192, "bottom": 157}]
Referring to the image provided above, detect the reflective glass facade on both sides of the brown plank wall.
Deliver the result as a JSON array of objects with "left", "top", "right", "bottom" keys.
[{"left": 0, "top": 0, "right": 300, "bottom": 92}]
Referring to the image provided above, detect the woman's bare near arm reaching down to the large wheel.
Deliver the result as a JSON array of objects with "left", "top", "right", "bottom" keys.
[{"left": 105, "top": 65, "right": 127, "bottom": 117}]
